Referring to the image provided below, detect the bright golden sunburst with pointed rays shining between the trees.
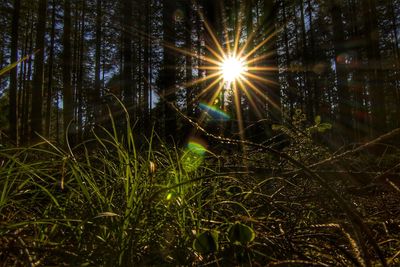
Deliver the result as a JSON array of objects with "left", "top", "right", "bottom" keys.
[{"left": 158, "top": 2, "right": 279, "bottom": 142}]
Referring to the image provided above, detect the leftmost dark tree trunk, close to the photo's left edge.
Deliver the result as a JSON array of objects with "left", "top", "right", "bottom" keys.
[{"left": 9, "top": 0, "right": 21, "bottom": 146}]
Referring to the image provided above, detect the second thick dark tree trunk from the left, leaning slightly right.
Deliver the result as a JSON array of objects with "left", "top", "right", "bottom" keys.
[{"left": 31, "top": 0, "right": 47, "bottom": 142}]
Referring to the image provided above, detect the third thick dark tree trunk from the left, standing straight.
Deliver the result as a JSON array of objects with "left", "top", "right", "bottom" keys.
[{"left": 62, "top": 0, "right": 74, "bottom": 141}]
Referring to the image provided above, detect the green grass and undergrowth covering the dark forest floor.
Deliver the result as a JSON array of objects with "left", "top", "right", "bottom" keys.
[{"left": 0, "top": 108, "right": 400, "bottom": 266}]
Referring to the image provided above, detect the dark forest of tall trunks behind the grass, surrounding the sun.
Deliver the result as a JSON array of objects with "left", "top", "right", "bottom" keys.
[{"left": 0, "top": 0, "right": 400, "bottom": 145}]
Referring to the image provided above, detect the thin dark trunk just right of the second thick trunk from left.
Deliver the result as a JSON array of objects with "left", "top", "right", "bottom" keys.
[{"left": 45, "top": 0, "right": 58, "bottom": 137}]
